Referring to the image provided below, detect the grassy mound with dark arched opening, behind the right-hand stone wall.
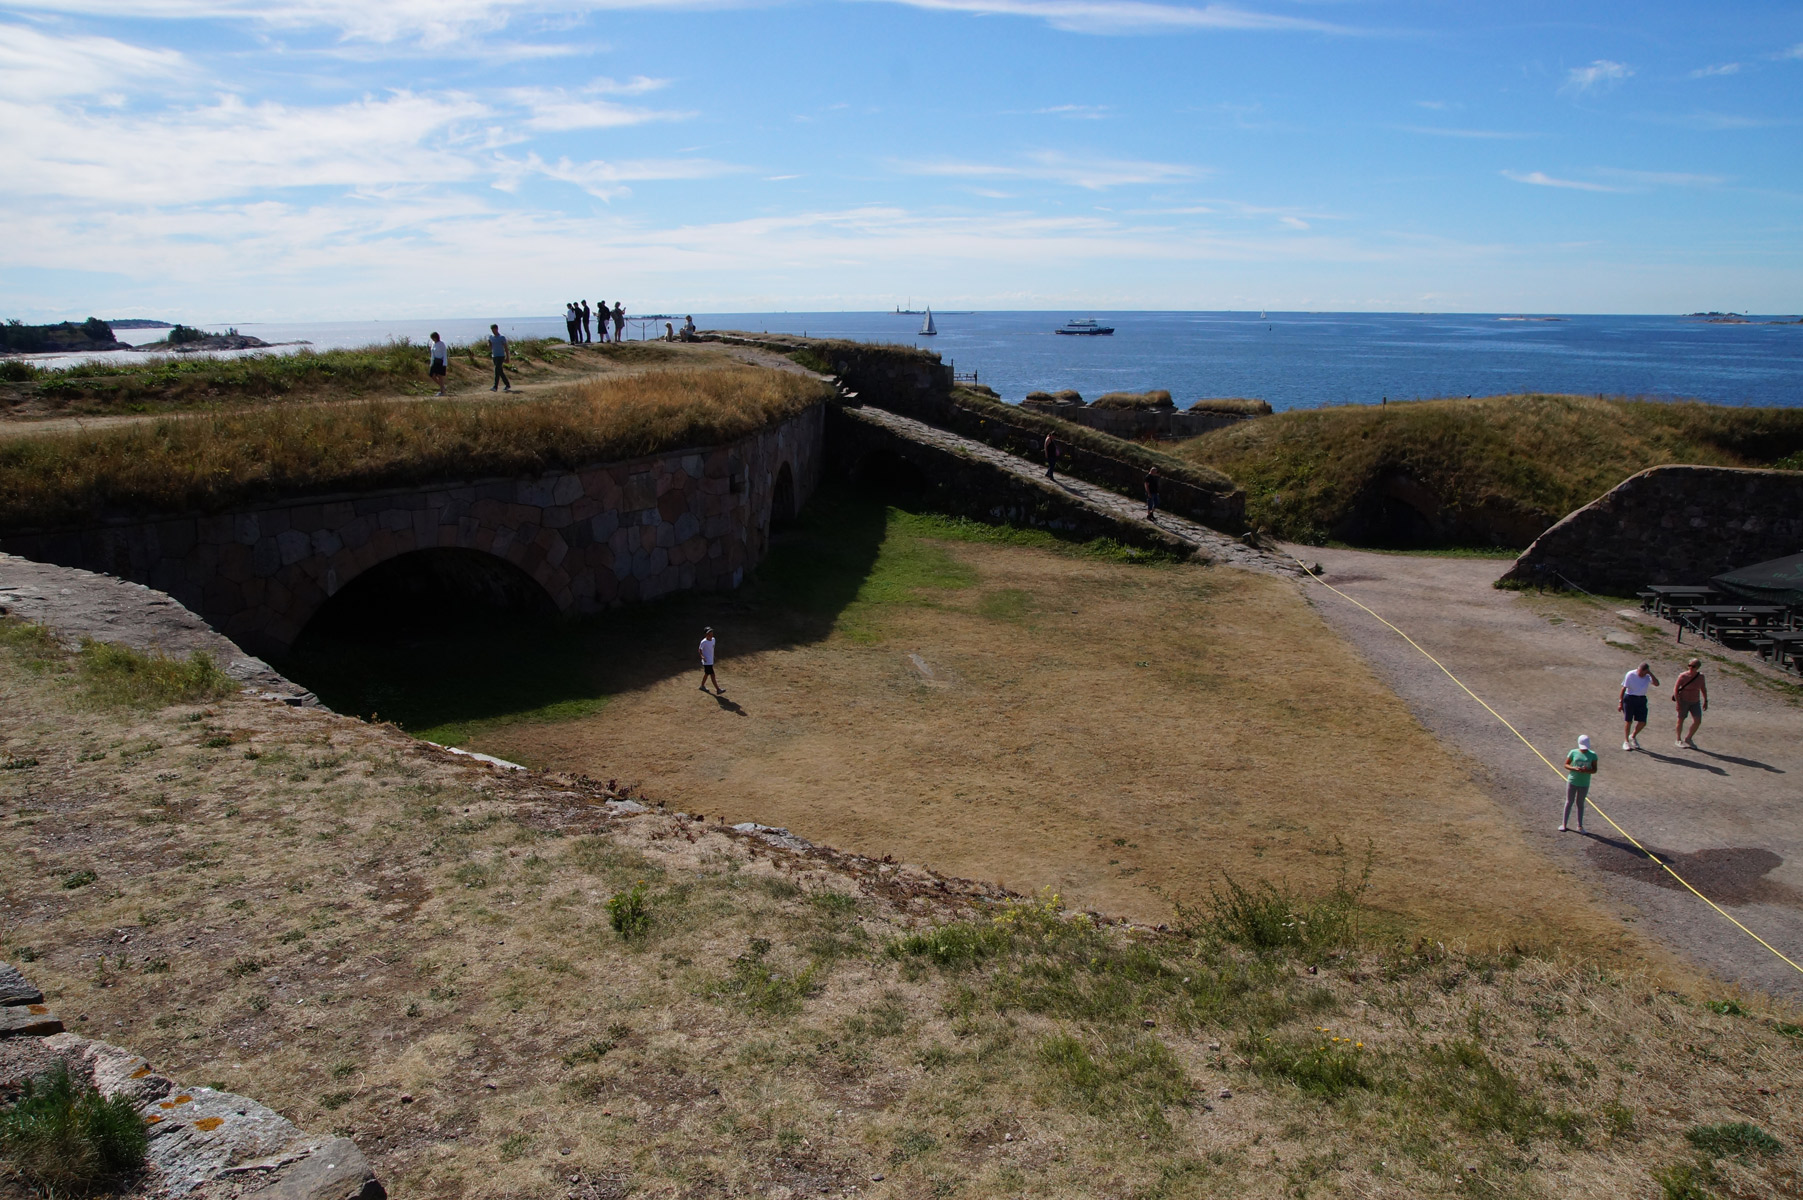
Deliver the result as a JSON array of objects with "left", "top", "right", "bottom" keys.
[{"left": 1176, "top": 395, "right": 1803, "bottom": 548}]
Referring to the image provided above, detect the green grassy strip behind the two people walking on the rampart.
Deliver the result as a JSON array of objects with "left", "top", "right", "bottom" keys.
[{"left": 0, "top": 339, "right": 563, "bottom": 414}]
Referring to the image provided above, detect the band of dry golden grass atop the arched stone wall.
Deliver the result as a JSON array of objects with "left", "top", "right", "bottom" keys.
[{"left": 0, "top": 368, "right": 828, "bottom": 528}]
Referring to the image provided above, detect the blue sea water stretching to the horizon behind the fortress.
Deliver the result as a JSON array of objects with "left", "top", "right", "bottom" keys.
[{"left": 36, "top": 312, "right": 1803, "bottom": 409}]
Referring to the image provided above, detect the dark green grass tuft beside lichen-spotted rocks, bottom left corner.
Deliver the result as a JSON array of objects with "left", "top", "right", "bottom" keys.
[{"left": 0, "top": 1065, "right": 150, "bottom": 1196}]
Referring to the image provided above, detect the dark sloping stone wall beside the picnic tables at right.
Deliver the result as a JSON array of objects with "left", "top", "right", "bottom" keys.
[{"left": 1498, "top": 467, "right": 1803, "bottom": 596}]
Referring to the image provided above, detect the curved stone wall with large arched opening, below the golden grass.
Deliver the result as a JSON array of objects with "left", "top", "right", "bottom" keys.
[{"left": 0, "top": 405, "right": 824, "bottom": 654}]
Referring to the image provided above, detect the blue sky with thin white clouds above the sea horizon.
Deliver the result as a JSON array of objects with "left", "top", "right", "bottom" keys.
[{"left": 0, "top": 0, "right": 1803, "bottom": 323}]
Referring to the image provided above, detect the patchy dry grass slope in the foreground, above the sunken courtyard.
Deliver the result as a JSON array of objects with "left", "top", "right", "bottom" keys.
[{"left": 0, "top": 616, "right": 1803, "bottom": 1200}]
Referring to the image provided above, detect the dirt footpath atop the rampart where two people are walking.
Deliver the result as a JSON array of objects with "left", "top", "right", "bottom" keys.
[{"left": 0, "top": 342, "right": 789, "bottom": 438}]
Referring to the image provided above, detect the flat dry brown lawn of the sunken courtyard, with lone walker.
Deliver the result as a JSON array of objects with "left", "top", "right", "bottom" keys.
[{"left": 467, "top": 514, "right": 1670, "bottom": 962}]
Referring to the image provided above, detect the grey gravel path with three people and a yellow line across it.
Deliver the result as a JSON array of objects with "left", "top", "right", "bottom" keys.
[{"left": 1295, "top": 548, "right": 1803, "bottom": 996}]
